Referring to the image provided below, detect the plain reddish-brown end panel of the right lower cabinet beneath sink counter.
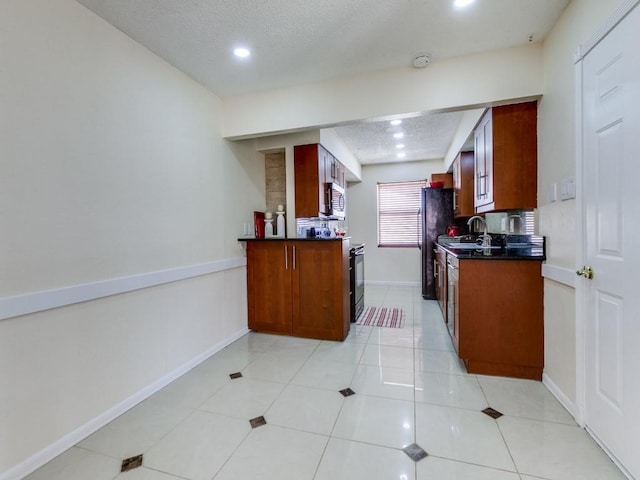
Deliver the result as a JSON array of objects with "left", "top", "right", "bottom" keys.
[{"left": 454, "top": 259, "right": 544, "bottom": 380}]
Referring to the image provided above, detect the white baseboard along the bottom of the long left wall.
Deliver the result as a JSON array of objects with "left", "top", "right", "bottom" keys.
[{"left": 0, "top": 328, "right": 250, "bottom": 480}]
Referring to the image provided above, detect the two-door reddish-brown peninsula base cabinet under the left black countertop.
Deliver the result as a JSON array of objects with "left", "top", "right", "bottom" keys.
[{"left": 247, "top": 239, "right": 350, "bottom": 340}]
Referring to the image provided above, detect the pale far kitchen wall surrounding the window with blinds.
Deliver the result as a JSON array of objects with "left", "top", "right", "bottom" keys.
[{"left": 347, "top": 160, "right": 443, "bottom": 285}]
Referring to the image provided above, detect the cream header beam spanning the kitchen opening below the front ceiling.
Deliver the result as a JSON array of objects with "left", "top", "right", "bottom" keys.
[{"left": 223, "top": 44, "right": 542, "bottom": 138}]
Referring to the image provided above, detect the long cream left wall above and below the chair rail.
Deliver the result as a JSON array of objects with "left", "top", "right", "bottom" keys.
[{"left": 0, "top": 0, "right": 264, "bottom": 478}]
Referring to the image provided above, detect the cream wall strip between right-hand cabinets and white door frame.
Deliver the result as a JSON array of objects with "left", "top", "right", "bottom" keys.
[{"left": 538, "top": 0, "right": 619, "bottom": 407}]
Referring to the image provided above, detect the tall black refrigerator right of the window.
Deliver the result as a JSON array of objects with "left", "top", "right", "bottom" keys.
[{"left": 420, "top": 188, "right": 456, "bottom": 300}]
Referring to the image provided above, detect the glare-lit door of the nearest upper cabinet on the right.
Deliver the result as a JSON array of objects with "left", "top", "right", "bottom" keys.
[{"left": 474, "top": 110, "right": 493, "bottom": 209}]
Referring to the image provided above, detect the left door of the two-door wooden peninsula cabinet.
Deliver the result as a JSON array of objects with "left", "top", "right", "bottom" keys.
[{"left": 247, "top": 241, "right": 292, "bottom": 335}]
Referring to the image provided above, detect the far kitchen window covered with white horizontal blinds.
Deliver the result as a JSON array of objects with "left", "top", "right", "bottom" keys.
[{"left": 378, "top": 180, "right": 427, "bottom": 247}]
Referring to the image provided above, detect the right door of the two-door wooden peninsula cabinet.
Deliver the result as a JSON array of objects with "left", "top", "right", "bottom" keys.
[{"left": 292, "top": 241, "right": 348, "bottom": 340}]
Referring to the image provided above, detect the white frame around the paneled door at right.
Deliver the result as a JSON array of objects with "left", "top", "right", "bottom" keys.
[{"left": 574, "top": 0, "right": 640, "bottom": 470}]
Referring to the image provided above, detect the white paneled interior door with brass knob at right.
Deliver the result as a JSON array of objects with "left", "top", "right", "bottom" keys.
[{"left": 580, "top": 2, "right": 640, "bottom": 480}]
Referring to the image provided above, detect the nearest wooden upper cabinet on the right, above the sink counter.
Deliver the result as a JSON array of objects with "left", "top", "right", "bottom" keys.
[{"left": 474, "top": 102, "right": 538, "bottom": 213}]
